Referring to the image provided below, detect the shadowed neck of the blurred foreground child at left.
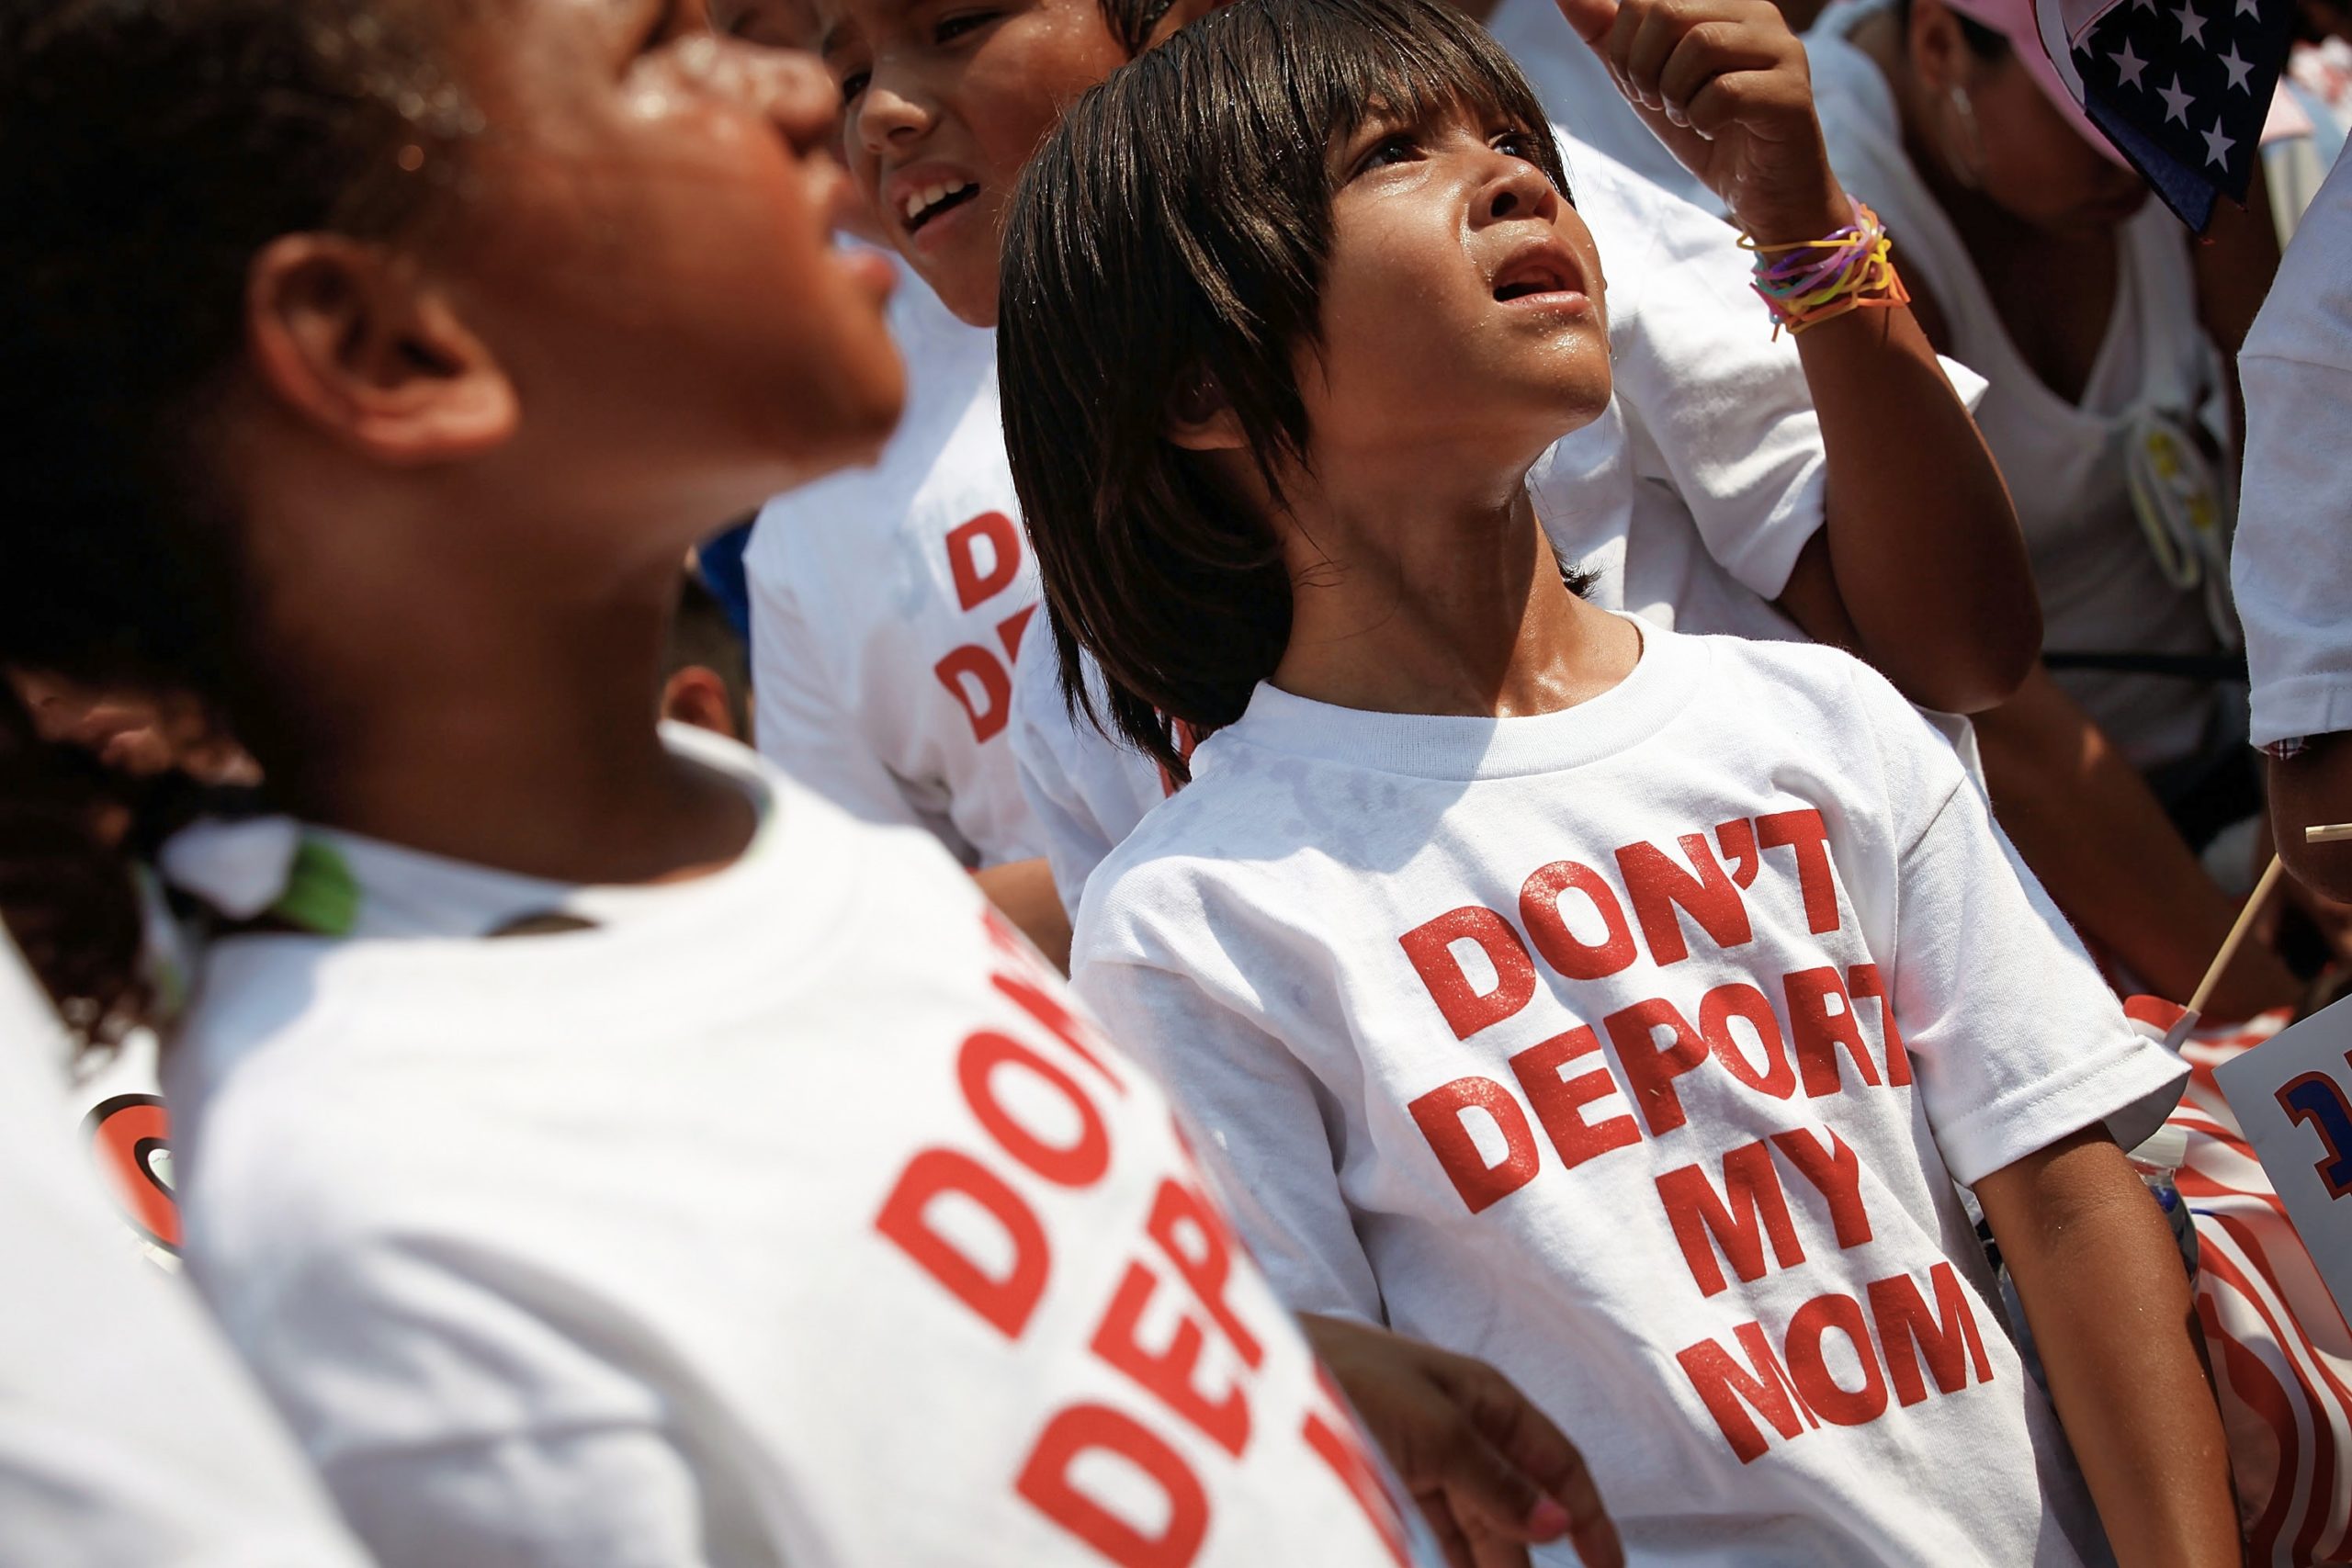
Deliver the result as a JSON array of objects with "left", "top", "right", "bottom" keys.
[{"left": 241, "top": 536, "right": 755, "bottom": 884}]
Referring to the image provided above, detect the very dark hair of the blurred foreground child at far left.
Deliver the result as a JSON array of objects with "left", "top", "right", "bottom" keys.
[{"left": 0, "top": 0, "right": 470, "bottom": 1032}]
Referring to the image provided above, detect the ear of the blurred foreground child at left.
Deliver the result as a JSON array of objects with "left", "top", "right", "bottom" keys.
[{"left": 244, "top": 235, "right": 520, "bottom": 468}]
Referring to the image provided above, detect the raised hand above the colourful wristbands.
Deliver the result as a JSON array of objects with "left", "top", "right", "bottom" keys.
[{"left": 1559, "top": 0, "right": 1851, "bottom": 244}]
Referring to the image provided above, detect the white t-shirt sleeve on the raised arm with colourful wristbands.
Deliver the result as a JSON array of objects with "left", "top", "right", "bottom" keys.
[{"left": 1588, "top": 154, "right": 1827, "bottom": 600}]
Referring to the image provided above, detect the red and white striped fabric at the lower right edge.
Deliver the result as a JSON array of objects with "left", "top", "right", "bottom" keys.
[{"left": 2126, "top": 997, "right": 2352, "bottom": 1568}]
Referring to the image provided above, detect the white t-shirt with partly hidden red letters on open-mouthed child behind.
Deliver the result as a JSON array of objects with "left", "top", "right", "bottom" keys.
[{"left": 743, "top": 278, "right": 1042, "bottom": 867}]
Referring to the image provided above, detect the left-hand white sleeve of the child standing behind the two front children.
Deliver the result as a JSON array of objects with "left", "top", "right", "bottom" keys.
[{"left": 743, "top": 513, "right": 944, "bottom": 832}]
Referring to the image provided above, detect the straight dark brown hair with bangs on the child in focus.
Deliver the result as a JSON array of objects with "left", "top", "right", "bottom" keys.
[{"left": 997, "top": 0, "right": 1569, "bottom": 778}]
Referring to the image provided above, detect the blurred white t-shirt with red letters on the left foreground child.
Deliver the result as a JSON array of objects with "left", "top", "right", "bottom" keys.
[{"left": 167, "top": 731, "right": 1430, "bottom": 1568}]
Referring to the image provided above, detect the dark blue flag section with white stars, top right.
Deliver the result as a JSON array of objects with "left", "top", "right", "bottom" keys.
[{"left": 2034, "top": 0, "right": 2296, "bottom": 232}]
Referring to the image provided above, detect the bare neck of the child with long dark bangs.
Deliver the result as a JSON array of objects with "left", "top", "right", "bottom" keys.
[{"left": 1272, "top": 479, "right": 1642, "bottom": 717}]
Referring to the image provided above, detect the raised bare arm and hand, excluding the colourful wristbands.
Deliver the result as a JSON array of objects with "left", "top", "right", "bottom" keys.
[{"left": 1559, "top": 0, "right": 2041, "bottom": 712}]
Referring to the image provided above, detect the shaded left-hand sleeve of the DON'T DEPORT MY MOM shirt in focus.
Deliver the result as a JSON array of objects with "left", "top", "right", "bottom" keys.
[{"left": 1070, "top": 959, "right": 1385, "bottom": 1324}]
